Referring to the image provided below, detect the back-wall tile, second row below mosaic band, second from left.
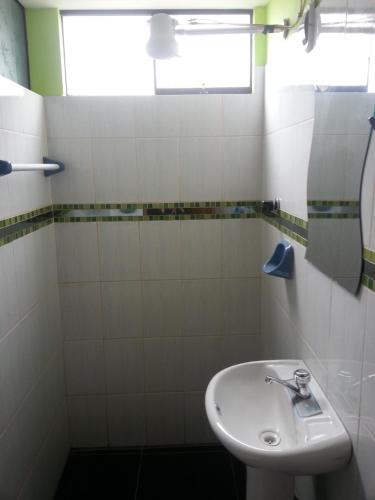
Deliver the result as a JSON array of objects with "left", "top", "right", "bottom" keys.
[{"left": 101, "top": 281, "right": 142, "bottom": 338}]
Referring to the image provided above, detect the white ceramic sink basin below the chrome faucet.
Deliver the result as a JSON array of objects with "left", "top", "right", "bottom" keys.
[{"left": 206, "top": 360, "right": 351, "bottom": 475}]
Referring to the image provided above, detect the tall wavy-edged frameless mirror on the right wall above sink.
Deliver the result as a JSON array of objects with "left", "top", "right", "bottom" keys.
[{"left": 306, "top": 2, "right": 375, "bottom": 294}]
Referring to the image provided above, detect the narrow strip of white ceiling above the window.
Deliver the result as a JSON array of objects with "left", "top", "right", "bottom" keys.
[{"left": 21, "top": 0, "right": 268, "bottom": 10}]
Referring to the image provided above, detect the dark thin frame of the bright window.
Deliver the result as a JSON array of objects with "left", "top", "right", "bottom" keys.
[{"left": 60, "top": 9, "right": 254, "bottom": 95}]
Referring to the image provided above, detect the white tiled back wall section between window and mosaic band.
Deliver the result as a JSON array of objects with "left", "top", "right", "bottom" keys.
[{"left": 45, "top": 68, "right": 263, "bottom": 205}]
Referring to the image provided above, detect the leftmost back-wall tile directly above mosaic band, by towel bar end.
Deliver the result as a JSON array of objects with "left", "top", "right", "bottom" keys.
[{"left": 48, "top": 139, "right": 95, "bottom": 203}]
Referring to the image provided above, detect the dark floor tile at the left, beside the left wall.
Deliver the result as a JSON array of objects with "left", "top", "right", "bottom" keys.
[{"left": 55, "top": 452, "right": 141, "bottom": 500}]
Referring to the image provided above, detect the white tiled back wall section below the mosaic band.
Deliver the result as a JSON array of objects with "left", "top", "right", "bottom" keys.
[{"left": 56, "top": 219, "right": 261, "bottom": 446}]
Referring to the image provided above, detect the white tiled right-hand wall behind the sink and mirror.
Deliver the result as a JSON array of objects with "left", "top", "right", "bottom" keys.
[{"left": 261, "top": 27, "right": 375, "bottom": 500}]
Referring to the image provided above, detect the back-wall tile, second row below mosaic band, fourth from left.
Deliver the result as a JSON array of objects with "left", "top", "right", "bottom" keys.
[{"left": 182, "top": 279, "right": 223, "bottom": 336}]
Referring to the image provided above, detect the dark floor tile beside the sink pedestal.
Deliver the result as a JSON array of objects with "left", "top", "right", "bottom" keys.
[{"left": 137, "top": 448, "right": 237, "bottom": 500}]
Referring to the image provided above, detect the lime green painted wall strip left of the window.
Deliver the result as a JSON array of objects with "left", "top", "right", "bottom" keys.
[{"left": 25, "top": 9, "right": 64, "bottom": 96}]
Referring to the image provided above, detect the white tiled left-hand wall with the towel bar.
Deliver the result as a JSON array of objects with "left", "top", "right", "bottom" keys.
[{"left": 0, "top": 77, "right": 69, "bottom": 500}]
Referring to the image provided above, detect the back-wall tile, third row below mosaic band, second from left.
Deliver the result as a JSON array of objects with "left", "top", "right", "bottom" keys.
[{"left": 104, "top": 339, "right": 144, "bottom": 394}]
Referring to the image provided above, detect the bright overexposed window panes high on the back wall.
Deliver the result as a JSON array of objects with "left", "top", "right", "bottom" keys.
[{"left": 62, "top": 11, "right": 252, "bottom": 95}]
